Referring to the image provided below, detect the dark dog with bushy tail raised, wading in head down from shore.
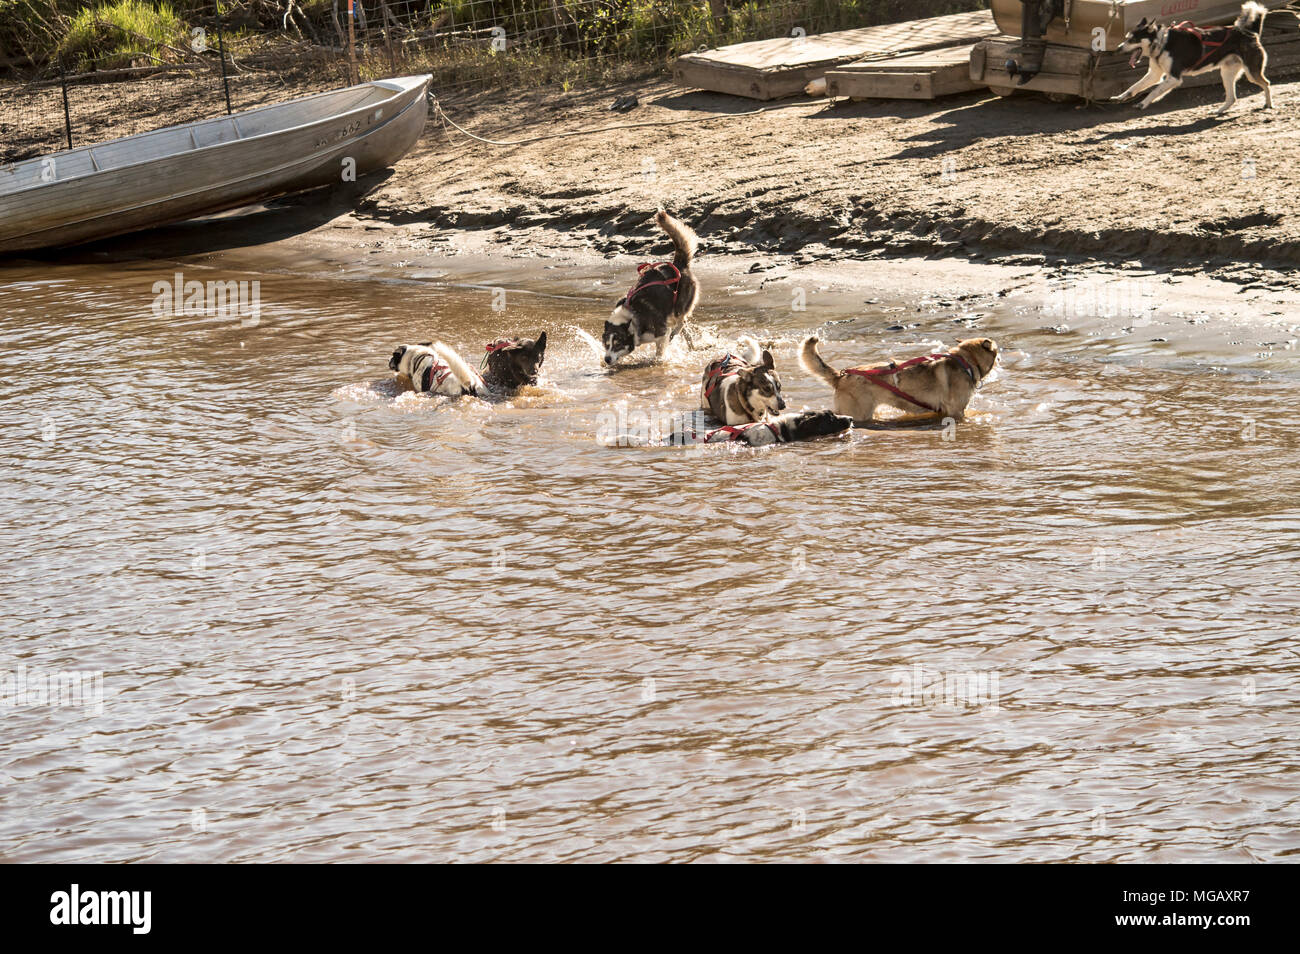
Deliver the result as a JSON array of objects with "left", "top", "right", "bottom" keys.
[{"left": 602, "top": 209, "right": 699, "bottom": 365}]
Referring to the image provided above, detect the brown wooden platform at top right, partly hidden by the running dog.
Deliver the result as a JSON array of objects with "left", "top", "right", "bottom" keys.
[{"left": 970, "top": 10, "right": 1300, "bottom": 100}]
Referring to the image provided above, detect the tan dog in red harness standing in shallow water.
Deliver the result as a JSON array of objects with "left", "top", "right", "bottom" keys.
[{"left": 800, "top": 338, "right": 997, "bottom": 424}]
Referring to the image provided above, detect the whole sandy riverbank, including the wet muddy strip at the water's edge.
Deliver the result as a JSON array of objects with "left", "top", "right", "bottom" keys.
[{"left": 10, "top": 65, "right": 1300, "bottom": 352}]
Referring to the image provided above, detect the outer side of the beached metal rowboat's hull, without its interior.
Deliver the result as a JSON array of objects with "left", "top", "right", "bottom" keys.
[{"left": 0, "top": 77, "right": 428, "bottom": 253}]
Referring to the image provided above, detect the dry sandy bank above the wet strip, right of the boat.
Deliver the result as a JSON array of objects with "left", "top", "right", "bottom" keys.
[{"left": 360, "top": 74, "right": 1300, "bottom": 289}]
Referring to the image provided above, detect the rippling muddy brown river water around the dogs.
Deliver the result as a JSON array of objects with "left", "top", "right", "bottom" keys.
[{"left": 0, "top": 248, "right": 1300, "bottom": 862}]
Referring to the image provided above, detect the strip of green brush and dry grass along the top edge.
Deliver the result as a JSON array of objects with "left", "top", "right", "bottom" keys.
[{"left": 0, "top": 0, "right": 987, "bottom": 84}]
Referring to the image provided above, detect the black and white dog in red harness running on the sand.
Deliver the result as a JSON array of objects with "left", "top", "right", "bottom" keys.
[{"left": 1114, "top": 3, "right": 1273, "bottom": 113}]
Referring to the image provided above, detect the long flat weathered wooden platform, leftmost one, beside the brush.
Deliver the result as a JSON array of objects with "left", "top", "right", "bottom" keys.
[{"left": 672, "top": 10, "right": 997, "bottom": 100}]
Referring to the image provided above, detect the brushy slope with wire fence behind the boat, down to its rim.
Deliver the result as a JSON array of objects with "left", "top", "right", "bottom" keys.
[{"left": 0, "top": 0, "right": 987, "bottom": 162}]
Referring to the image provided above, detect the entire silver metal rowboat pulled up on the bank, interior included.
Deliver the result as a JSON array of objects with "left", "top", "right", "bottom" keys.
[{"left": 0, "top": 75, "right": 429, "bottom": 253}]
